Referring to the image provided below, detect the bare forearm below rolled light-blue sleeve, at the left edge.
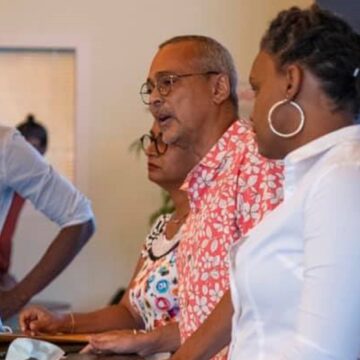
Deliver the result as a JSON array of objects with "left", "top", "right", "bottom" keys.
[{"left": 0, "top": 220, "right": 94, "bottom": 318}]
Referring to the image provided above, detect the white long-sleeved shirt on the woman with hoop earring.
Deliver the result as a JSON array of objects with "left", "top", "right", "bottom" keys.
[{"left": 229, "top": 125, "right": 360, "bottom": 360}]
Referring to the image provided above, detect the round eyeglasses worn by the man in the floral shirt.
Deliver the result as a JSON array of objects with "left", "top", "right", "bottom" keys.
[{"left": 140, "top": 71, "right": 219, "bottom": 105}]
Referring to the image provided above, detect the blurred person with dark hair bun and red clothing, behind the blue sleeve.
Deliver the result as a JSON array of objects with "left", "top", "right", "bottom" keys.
[{"left": 0, "top": 114, "right": 48, "bottom": 290}]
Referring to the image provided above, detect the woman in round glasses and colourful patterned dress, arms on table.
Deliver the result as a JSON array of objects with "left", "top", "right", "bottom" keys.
[{"left": 20, "top": 123, "right": 195, "bottom": 356}]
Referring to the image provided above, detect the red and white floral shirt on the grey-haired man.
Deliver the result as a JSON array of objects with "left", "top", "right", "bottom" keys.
[{"left": 176, "top": 121, "right": 283, "bottom": 359}]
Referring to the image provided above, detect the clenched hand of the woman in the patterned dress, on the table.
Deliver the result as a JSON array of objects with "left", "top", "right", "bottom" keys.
[{"left": 19, "top": 306, "right": 66, "bottom": 336}]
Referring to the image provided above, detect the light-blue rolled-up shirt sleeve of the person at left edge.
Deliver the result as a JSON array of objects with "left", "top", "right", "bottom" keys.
[{"left": 0, "top": 131, "right": 93, "bottom": 227}]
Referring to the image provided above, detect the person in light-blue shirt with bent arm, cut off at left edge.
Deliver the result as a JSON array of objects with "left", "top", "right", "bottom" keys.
[{"left": 0, "top": 114, "right": 94, "bottom": 319}]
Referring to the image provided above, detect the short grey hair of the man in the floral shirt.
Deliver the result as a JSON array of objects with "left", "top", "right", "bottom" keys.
[{"left": 159, "top": 35, "right": 239, "bottom": 115}]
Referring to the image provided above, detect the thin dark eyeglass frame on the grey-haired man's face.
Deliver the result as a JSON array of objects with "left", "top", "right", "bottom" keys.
[{"left": 139, "top": 71, "right": 220, "bottom": 105}]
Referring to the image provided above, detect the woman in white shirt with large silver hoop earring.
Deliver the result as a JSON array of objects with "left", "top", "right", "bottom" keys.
[{"left": 229, "top": 6, "right": 360, "bottom": 360}]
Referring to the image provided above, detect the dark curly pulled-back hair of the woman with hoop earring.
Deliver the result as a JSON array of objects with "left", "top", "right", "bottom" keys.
[{"left": 260, "top": 5, "right": 360, "bottom": 117}]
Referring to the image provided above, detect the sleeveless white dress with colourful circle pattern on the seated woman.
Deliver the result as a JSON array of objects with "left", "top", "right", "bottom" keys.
[{"left": 129, "top": 214, "right": 183, "bottom": 331}]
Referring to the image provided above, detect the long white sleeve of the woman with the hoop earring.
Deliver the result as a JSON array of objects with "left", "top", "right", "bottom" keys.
[{"left": 281, "top": 165, "right": 360, "bottom": 360}]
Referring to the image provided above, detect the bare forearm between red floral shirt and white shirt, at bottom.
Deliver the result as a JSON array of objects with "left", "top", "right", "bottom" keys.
[{"left": 171, "top": 290, "right": 233, "bottom": 360}]
